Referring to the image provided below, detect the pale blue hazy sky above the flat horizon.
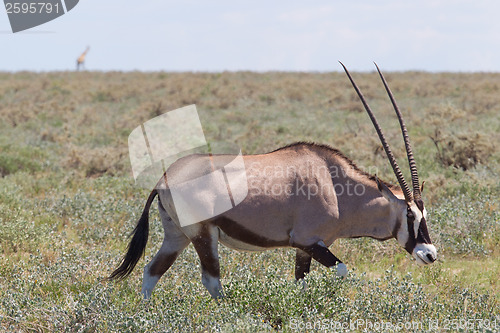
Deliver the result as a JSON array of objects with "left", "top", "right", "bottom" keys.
[{"left": 0, "top": 0, "right": 500, "bottom": 72}]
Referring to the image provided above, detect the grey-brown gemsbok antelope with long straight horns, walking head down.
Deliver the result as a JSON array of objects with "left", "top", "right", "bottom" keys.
[{"left": 109, "top": 63, "right": 437, "bottom": 298}]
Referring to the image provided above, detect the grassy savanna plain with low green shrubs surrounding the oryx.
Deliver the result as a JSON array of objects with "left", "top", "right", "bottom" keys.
[{"left": 0, "top": 72, "right": 500, "bottom": 332}]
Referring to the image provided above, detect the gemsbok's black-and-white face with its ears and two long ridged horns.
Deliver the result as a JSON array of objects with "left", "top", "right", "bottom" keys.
[{"left": 340, "top": 63, "right": 437, "bottom": 265}]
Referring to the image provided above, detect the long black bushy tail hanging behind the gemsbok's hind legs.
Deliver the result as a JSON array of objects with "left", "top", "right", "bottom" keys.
[{"left": 108, "top": 189, "right": 158, "bottom": 280}]
